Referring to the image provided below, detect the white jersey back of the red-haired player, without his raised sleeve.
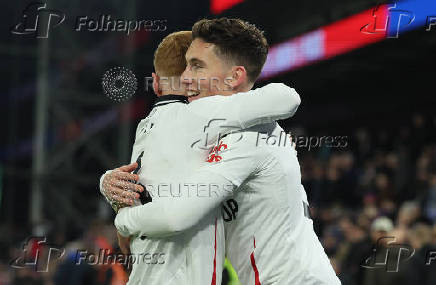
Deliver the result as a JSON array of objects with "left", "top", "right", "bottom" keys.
[{"left": 124, "top": 96, "right": 224, "bottom": 285}]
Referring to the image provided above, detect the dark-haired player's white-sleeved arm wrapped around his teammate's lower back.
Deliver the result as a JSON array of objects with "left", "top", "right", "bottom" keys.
[{"left": 115, "top": 135, "right": 265, "bottom": 237}]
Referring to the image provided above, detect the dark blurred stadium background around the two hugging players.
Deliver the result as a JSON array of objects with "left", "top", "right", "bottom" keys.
[{"left": 0, "top": 0, "right": 436, "bottom": 285}]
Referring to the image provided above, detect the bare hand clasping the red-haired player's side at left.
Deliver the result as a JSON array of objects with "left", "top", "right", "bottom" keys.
[{"left": 102, "top": 162, "right": 144, "bottom": 205}]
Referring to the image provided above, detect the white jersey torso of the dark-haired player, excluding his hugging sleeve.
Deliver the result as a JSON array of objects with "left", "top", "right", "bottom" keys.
[{"left": 216, "top": 123, "right": 340, "bottom": 285}]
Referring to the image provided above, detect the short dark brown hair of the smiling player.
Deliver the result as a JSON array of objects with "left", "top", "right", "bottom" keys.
[{"left": 192, "top": 18, "right": 268, "bottom": 82}]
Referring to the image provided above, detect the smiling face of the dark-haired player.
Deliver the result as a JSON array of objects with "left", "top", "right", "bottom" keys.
[{"left": 182, "top": 39, "right": 234, "bottom": 102}]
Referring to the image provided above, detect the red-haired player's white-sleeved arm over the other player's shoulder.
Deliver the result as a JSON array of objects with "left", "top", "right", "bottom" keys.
[{"left": 189, "top": 83, "right": 301, "bottom": 134}]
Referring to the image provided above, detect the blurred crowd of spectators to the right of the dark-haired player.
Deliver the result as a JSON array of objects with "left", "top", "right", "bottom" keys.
[{"left": 299, "top": 114, "right": 436, "bottom": 285}]
